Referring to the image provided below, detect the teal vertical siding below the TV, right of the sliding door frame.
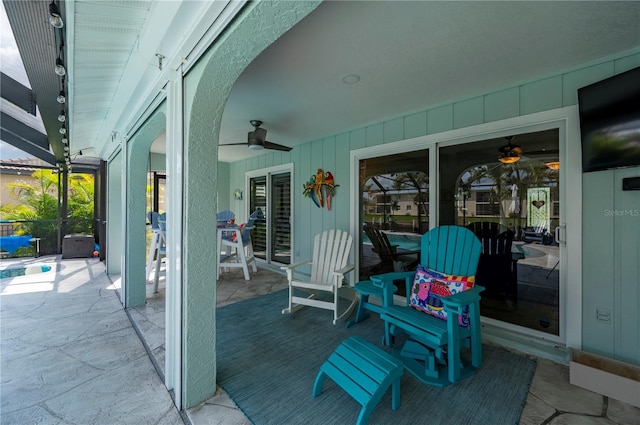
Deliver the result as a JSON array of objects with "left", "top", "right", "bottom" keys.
[{"left": 582, "top": 167, "right": 640, "bottom": 365}]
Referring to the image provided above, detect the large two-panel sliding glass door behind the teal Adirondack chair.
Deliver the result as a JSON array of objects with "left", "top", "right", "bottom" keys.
[{"left": 353, "top": 125, "right": 570, "bottom": 341}]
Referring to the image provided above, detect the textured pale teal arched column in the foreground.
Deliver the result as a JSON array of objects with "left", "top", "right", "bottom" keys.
[{"left": 182, "top": 1, "right": 319, "bottom": 407}]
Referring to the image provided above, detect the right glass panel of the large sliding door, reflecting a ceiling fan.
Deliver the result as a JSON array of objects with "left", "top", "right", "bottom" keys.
[{"left": 439, "top": 129, "right": 563, "bottom": 336}]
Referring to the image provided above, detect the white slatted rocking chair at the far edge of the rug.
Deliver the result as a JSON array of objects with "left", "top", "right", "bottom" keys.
[{"left": 281, "top": 230, "right": 357, "bottom": 325}]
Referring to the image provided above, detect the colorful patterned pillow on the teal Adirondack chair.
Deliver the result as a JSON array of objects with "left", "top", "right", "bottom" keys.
[{"left": 409, "top": 265, "right": 475, "bottom": 326}]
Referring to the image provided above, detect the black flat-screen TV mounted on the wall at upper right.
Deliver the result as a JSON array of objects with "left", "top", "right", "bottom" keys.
[{"left": 578, "top": 67, "right": 640, "bottom": 172}]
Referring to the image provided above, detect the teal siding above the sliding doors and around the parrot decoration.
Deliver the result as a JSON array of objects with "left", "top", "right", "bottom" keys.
[{"left": 230, "top": 53, "right": 640, "bottom": 272}]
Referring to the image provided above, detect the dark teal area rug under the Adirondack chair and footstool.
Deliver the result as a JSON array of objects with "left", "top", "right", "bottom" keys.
[{"left": 217, "top": 291, "right": 535, "bottom": 425}]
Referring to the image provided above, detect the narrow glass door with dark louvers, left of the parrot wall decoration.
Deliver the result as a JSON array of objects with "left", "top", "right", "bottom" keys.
[{"left": 247, "top": 166, "right": 292, "bottom": 264}]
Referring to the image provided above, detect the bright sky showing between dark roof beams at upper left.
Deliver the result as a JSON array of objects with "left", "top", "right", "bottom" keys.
[{"left": 0, "top": 1, "right": 38, "bottom": 160}]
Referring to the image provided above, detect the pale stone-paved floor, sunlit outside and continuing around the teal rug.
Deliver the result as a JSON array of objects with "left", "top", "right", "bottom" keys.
[{"left": 5, "top": 256, "right": 640, "bottom": 425}]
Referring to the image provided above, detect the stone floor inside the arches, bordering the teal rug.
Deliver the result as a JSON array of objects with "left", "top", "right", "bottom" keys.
[{"left": 129, "top": 258, "right": 640, "bottom": 425}]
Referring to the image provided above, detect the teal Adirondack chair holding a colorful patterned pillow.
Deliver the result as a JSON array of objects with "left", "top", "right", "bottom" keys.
[{"left": 356, "top": 226, "right": 484, "bottom": 386}]
